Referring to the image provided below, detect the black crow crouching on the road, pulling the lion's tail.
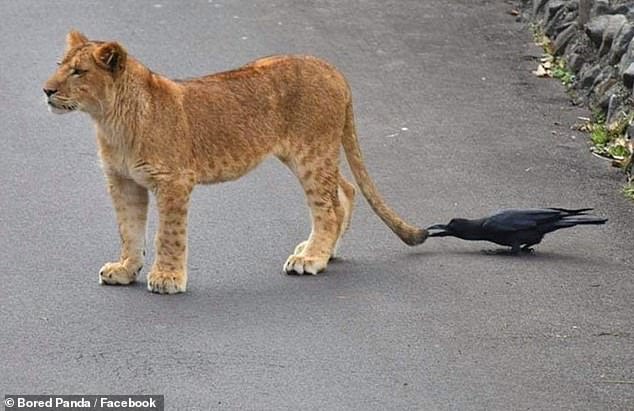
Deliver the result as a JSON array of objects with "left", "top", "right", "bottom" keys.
[{"left": 427, "top": 208, "right": 608, "bottom": 254}]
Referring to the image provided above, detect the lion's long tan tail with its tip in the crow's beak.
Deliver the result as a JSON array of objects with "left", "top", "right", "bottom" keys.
[{"left": 342, "top": 102, "right": 429, "bottom": 245}]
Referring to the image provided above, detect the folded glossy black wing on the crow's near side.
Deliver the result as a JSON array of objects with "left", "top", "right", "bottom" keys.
[{"left": 482, "top": 208, "right": 561, "bottom": 231}]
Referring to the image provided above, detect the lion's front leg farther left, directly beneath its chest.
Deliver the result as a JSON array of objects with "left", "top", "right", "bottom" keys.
[{"left": 99, "top": 175, "right": 148, "bottom": 284}]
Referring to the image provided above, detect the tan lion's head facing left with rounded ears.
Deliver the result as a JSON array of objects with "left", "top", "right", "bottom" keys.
[{"left": 44, "top": 31, "right": 127, "bottom": 114}]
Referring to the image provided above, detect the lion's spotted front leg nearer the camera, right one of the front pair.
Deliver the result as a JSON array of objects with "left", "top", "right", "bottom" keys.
[{"left": 147, "top": 182, "right": 193, "bottom": 294}]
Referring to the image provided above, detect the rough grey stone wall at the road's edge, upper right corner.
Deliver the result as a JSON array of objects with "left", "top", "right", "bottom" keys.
[{"left": 521, "top": 0, "right": 634, "bottom": 121}]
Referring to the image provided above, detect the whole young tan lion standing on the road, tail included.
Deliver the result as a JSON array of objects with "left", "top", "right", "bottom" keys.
[{"left": 45, "top": 32, "right": 427, "bottom": 293}]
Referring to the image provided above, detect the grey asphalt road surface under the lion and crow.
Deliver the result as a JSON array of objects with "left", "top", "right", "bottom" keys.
[{"left": 0, "top": 0, "right": 634, "bottom": 410}]
